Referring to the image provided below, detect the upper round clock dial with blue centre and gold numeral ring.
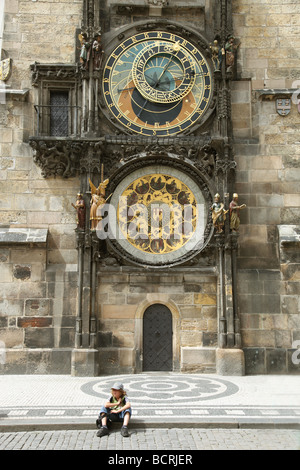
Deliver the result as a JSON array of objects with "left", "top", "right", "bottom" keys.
[{"left": 102, "top": 31, "right": 213, "bottom": 137}]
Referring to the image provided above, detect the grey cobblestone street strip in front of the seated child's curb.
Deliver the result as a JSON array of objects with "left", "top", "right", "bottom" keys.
[{"left": 0, "top": 428, "right": 300, "bottom": 450}]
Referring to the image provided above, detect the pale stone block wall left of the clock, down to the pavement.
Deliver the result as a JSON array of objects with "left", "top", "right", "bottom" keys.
[{"left": 0, "top": 0, "right": 82, "bottom": 374}]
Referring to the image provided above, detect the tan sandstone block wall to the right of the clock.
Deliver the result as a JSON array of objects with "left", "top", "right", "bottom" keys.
[{"left": 232, "top": 0, "right": 300, "bottom": 374}]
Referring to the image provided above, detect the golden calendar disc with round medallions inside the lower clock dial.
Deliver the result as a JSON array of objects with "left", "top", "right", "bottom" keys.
[{"left": 117, "top": 174, "right": 197, "bottom": 255}]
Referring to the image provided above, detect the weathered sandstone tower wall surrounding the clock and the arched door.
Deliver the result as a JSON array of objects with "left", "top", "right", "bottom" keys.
[{"left": 0, "top": 0, "right": 300, "bottom": 375}]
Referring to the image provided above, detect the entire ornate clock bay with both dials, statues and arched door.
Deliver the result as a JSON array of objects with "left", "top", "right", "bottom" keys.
[{"left": 30, "top": 0, "right": 241, "bottom": 375}]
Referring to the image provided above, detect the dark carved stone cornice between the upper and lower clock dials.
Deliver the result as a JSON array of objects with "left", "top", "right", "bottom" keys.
[{"left": 29, "top": 136, "right": 230, "bottom": 183}]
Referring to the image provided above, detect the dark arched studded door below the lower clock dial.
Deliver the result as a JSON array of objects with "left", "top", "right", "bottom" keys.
[{"left": 143, "top": 304, "right": 173, "bottom": 371}]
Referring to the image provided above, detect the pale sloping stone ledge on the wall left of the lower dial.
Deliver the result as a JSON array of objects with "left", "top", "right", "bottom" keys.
[{"left": 0, "top": 227, "right": 48, "bottom": 245}]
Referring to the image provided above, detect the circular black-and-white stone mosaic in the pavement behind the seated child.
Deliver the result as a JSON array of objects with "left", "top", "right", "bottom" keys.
[{"left": 81, "top": 374, "right": 239, "bottom": 404}]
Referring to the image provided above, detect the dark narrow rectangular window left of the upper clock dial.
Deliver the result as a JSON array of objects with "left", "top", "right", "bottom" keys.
[{"left": 50, "top": 90, "right": 69, "bottom": 137}]
